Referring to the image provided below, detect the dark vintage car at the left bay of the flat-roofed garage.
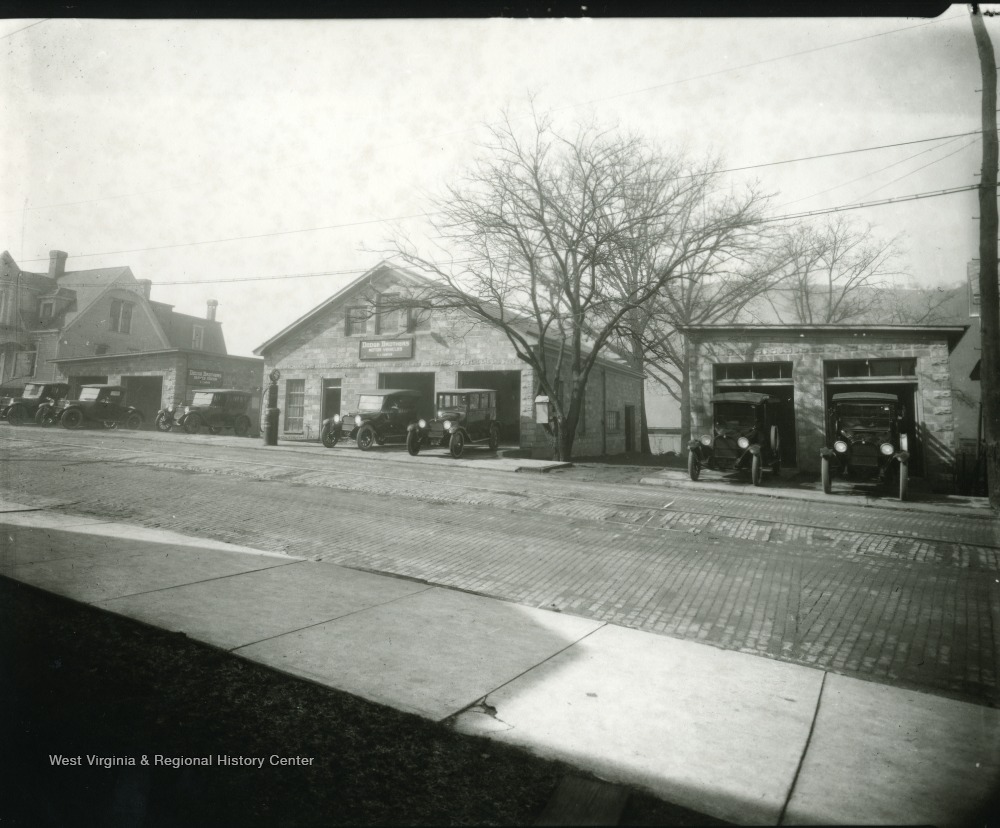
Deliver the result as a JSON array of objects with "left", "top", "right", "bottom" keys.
[{"left": 688, "top": 391, "right": 782, "bottom": 486}]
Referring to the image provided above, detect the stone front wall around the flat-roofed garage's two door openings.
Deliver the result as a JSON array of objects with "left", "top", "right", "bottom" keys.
[{"left": 691, "top": 328, "right": 955, "bottom": 491}]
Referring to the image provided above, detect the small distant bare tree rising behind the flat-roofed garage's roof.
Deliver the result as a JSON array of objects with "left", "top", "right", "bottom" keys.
[{"left": 765, "top": 216, "right": 903, "bottom": 325}]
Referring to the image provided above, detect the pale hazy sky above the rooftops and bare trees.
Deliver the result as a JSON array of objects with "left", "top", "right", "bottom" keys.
[{"left": 0, "top": 11, "right": 1000, "bottom": 355}]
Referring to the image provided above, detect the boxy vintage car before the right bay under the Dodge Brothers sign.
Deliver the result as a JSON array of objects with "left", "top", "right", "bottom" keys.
[{"left": 406, "top": 388, "right": 500, "bottom": 458}]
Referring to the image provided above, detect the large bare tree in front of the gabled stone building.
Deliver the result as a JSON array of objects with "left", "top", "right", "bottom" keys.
[{"left": 393, "top": 111, "right": 759, "bottom": 459}]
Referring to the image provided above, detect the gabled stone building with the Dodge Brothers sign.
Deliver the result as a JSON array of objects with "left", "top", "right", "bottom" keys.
[{"left": 254, "top": 262, "right": 642, "bottom": 457}]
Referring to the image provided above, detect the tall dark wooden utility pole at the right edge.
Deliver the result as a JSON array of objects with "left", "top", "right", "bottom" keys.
[{"left": 971, "top": 5, "right": 1000, "bottom": 510}]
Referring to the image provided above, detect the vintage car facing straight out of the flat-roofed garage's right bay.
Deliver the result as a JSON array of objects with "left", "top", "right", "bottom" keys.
[{"left": 820, "top": 391, "right": 910, "bottom": 500}]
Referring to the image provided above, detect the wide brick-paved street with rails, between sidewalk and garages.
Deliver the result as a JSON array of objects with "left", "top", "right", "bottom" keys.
[{"left": 0, "top": 425, "right": 1000, "bottom": 706}]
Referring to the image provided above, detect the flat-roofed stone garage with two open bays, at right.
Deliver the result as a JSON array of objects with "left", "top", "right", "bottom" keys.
[{"left": 684, "top": 325, "right": 966, "bottom": 491}]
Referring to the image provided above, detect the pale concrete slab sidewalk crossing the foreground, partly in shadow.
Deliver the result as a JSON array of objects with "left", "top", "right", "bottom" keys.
[{"left": 0, "top": 502, "right": 1000, "bottom": 825}]
